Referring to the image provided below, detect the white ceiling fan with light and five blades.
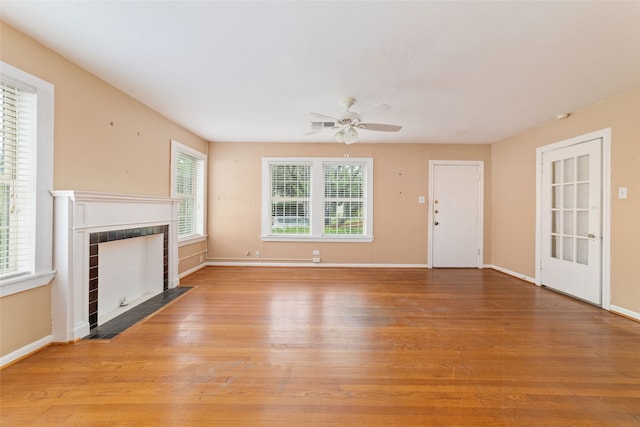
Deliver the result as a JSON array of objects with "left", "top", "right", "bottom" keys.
[{"left": 307, "top": 98, "right": 402, "bottom": 144}]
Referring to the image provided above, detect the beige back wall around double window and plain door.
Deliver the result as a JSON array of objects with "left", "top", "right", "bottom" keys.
[{"left": 208, "top": 143, "right": 491, "bottom": 264}]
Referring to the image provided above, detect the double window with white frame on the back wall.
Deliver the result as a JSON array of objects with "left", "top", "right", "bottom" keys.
[{"left": 262, "top": 158, "right": 373, "bottom": 242}]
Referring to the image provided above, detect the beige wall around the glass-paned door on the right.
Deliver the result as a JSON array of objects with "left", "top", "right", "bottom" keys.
[{"left": 491, "top": 88, "right": 640, "bottom": 313}]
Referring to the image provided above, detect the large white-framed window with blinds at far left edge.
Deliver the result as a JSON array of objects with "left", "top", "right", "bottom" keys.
[{"left": 0, "top": 63, "right": 54, "bottom": 296}]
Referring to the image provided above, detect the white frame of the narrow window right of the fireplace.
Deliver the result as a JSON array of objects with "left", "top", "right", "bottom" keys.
[{"left": 171, "top": 139, "right": 207, "bottom": 247}]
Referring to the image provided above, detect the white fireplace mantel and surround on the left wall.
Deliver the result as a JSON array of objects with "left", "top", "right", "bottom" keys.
[{"left": 52, "top": 190, "right": 180, "bottom": 342}]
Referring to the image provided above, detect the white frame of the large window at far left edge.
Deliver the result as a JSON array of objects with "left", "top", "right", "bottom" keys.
[{"left": 0, "top": 61, "right": 55, "bottom": 297}]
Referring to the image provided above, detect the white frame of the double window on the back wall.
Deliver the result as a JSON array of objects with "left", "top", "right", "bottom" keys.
[{"left": 261, "top": 157, "right": 374, "bottom": 242}]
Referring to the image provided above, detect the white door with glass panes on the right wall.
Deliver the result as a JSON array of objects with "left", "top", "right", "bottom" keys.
[{"left": 540, "top": 138, "right": 602, "bottom": 305}]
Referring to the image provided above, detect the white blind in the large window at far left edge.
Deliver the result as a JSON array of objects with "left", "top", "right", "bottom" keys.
[{"left": 0, "top": 82, "right": 36, "bottom": 279}]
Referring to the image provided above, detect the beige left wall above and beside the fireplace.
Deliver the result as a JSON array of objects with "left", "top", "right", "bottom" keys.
[{"left": 0, "top": 22, "right": 207, "bottom": 356}]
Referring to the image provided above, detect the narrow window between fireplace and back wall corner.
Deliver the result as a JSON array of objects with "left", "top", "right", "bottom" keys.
[{"left": 171, "top": 141, "right": 207, "bottom": 244}]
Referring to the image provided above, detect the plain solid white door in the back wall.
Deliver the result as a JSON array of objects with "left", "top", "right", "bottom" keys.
[{"left": 430, "top": 163, "right": 482, "bottom": 268}]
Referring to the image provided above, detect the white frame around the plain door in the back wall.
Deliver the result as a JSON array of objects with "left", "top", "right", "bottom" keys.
[{"left": 427, "top": 160, "right": 484, "bottom": 269}]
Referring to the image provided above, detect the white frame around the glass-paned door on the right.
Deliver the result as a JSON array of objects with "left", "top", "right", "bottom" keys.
[{"left": 535, "top": 128, "right": 611, "bottom": 310}]
